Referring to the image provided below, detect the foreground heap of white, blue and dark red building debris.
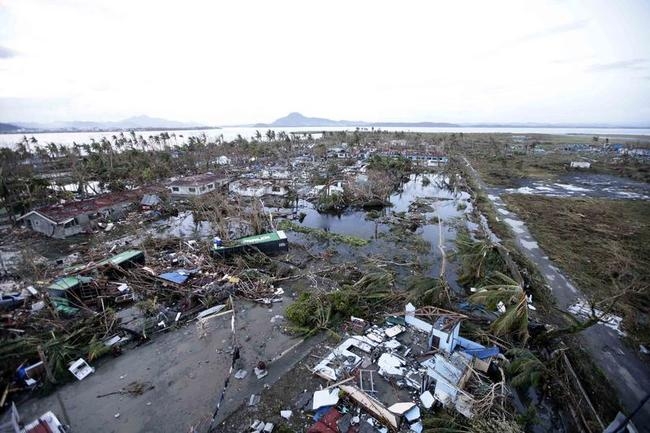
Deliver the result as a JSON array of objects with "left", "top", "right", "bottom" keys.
[{"left": 302, "top": 304, "right": 506, "bottom": 433}]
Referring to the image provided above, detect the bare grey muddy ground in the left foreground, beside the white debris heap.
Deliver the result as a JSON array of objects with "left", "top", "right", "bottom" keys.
[{"left": 7, "top": 299, "right": 318, "bottom": 433}]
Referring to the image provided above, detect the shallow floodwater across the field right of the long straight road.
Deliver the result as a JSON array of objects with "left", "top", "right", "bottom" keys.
[{"left": 488, "top": 174, "right": 650, "bottom": 200}]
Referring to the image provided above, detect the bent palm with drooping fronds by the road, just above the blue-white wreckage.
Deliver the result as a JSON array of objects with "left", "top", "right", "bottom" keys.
[{"left": 469, "top": 272, "right": 529, "bottom": 343}]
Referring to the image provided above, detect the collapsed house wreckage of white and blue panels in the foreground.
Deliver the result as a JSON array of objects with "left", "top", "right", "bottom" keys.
[{"left": 313, "top": 304, "right": 499, "bottom": 432}]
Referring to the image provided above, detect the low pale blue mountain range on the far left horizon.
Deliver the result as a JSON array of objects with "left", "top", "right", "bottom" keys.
[{"left": 10, "top": 116, "right": 207, "bottom": 132}]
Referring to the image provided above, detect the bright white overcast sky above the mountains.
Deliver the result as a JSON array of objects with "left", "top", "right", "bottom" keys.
[{"left": 0, "top": 0, "right": 650, "bottom": 126}]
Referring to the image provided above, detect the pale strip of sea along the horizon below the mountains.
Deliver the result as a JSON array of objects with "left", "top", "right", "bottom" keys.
[{"left": 0, "top": 126, "right": 650, "bottom": 148}]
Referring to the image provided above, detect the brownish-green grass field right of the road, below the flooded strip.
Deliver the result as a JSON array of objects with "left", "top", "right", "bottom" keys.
[{"left": 503, "top": 195, "right": 650, "bottom": 344}]
